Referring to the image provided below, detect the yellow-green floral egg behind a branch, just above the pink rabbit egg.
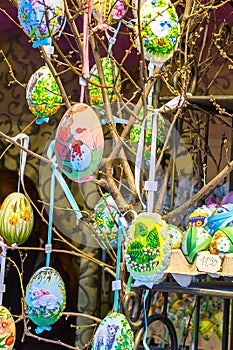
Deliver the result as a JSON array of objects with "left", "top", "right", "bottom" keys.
[{"left": 88, "top": 57, "right": 121, "bottom": 106}]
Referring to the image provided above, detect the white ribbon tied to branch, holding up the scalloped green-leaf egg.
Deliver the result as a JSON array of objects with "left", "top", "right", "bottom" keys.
[{"left": 135, "top": 96, "right": 185, "bottom": 212}]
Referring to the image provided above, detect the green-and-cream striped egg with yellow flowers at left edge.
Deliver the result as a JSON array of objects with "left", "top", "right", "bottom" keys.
[{"left": 0, "top": 192, "right": 34, "bottom": 245}]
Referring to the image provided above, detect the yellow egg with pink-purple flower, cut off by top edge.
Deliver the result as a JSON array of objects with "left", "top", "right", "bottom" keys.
[{"left": 93, "top": 0, "right": 129, "bottom": 29}]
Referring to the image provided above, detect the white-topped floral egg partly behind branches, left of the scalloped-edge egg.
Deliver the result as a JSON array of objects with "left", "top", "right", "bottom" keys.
[{"left": 92, "top": 193, "right": 120, "bottom": 248}]
